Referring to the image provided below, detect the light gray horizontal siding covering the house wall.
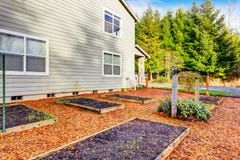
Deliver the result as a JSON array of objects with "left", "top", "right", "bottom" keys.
[{"left": 0, "top": 0, "right": 135, "bottom": 96}]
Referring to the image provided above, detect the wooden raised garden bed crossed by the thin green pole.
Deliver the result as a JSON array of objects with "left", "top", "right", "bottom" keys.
[{"left": 0, "top": 105, "right": 57, "bottom": 134}]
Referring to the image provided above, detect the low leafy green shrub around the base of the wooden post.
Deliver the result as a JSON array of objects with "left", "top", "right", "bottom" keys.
[{"left": 158, "top": 97, "right": 210, "bottom": 121}]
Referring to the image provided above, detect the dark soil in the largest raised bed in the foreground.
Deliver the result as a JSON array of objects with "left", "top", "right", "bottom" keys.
[{"left": 43, "top": 119, "right": 186, "bottom": 160}]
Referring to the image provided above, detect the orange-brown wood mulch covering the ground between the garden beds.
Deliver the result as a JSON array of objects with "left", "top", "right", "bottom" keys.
[{"left": 0, "top": 89, "right": 240, "bottom": 160}]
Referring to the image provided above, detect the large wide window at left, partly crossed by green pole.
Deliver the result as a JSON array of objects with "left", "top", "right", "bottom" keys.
[{"left": 0, "top": 29, "right": 48, "bottom": 74}]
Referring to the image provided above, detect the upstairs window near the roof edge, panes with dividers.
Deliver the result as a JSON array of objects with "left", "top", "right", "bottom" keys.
[{"left": 104, "top": 11, "right": 121, "bottom": 37}]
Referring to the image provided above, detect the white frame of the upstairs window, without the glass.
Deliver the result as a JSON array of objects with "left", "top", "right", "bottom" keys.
[{"left": 103, "top": 8, "right": 123, "bottom": 38}]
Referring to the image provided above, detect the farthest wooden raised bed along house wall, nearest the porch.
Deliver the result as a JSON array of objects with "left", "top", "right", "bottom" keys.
[{"left": 102, "top": 94, "right": 154, "bottom": 104}]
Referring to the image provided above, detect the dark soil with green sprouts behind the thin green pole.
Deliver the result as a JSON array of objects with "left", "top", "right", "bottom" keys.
[{"left": 0, "top": 105, "right": 51, "bottom": 128}]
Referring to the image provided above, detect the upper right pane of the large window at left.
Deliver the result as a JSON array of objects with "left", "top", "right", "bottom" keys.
[{"left": 27, "top": 38, "right": 46, "bottom": 56}]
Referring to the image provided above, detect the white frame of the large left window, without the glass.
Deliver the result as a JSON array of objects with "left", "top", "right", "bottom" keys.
[{"left": 0, "top": 29, "right": 49, "bottom": 75}]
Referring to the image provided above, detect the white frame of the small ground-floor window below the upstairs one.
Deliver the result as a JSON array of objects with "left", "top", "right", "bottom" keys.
[{"left": 102, "top": 51, "right": 122, "bottom": 77}]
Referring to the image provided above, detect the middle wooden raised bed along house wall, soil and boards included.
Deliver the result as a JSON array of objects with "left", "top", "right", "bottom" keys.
[{"left": 56, "top": 98, "right": 125, "bottom": 114}]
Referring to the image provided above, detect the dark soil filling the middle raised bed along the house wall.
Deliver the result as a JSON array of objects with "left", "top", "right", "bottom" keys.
[{"left": 69, "top": 98, "right": 120, "bottom": 109}]
